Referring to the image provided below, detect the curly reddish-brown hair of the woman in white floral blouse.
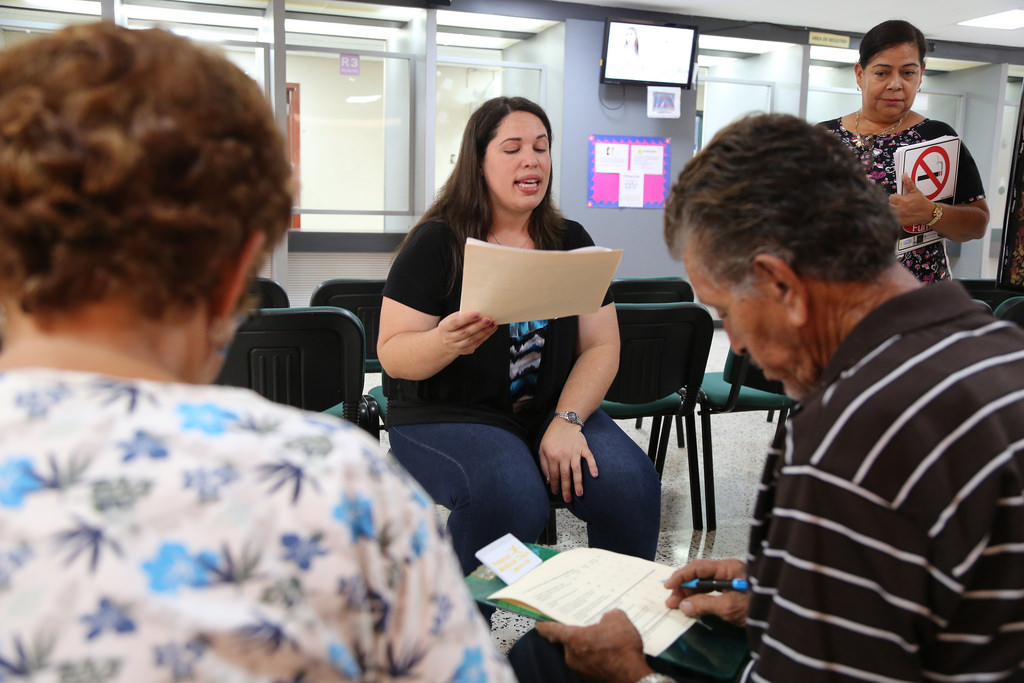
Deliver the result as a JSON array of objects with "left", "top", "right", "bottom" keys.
[{"left": 0, "top": 22, "right": 292, "bottom": 317}]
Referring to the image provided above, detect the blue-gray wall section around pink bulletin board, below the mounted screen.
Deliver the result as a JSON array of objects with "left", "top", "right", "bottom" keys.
[{"left": 555, "top": 19, "right": 696, "bottom": 278}]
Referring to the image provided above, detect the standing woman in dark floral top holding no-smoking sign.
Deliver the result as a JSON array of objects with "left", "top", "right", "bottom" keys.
[{"left": 821, "top": 19, "right": 988, "bottom": 284}]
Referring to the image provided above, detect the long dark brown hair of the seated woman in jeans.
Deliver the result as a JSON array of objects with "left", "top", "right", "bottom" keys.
[{"left": 398, "top": 97, "right": 563, "bottom": 291}]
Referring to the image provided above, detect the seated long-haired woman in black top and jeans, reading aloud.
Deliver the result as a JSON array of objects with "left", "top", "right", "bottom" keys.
[{"left": 377, "top": 97, "right": 660, "bottom": 572}]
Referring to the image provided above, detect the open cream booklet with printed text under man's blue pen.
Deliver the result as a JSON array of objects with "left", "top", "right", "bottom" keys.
[{"left": 488, "top": 548, "right": 695, "bottom": 656}]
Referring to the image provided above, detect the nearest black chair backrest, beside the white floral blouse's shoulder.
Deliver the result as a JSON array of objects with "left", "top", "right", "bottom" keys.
[{"left": 216, "top": 307, "right": 364, "bottom": 423}]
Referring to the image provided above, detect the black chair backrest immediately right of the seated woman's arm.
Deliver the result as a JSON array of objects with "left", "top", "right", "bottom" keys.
[{"left": 605, "top": 302, "right": 715, "bottom": 410}]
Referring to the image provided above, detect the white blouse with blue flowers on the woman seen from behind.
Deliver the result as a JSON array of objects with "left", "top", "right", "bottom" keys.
[{"left": 0, "top": 370, "right": 514, "bottom": 683}]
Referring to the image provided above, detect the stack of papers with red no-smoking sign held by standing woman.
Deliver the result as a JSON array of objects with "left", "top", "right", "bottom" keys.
[{"left": 893, "top": 135, "right": 961, "bottom": 255}]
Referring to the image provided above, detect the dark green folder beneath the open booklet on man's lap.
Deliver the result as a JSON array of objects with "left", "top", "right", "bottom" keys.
[{"left": 466, "top": 543, "right": 750, "bottom": 681}]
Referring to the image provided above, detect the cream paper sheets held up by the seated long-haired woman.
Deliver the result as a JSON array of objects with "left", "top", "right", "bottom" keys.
[{"left": 460, "top": 238, "right": 623, "bottom": 325}]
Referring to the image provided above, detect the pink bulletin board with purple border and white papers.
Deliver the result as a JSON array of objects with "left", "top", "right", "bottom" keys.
[{"left": 587, "top": 135, "right": 672, "bottom": 209}]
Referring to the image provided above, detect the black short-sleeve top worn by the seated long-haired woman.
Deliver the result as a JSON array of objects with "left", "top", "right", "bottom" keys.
[{"left": 384, "top": 220, "right": 611, "bottom": 438}]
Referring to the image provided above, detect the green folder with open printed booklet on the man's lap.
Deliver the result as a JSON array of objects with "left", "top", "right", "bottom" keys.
[{"left": 466, "top": 543, "right": 750, "bottom": 681}]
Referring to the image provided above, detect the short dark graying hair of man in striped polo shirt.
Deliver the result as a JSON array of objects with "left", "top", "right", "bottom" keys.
[{"left": 665, "top": 114, "right": 899, "bottom": 284}]
